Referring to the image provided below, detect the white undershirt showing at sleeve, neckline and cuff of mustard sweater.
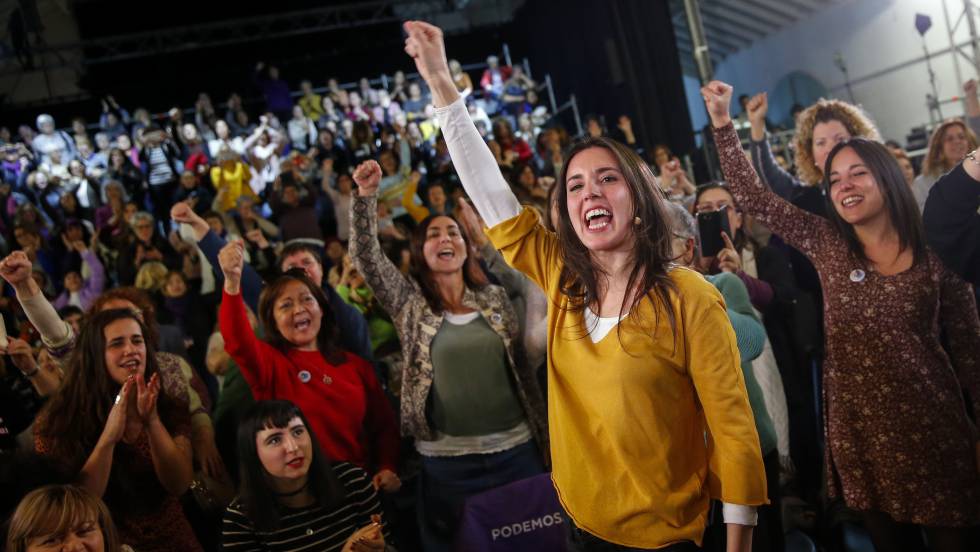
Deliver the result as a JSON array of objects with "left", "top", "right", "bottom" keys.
[{"left": 435, "top": 98, "right": 758, "bottom": 526}]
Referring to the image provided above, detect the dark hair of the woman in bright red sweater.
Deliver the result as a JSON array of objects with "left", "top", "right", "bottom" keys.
[{"left": 258, "top": 268, "right": 345, "bottom": 366}]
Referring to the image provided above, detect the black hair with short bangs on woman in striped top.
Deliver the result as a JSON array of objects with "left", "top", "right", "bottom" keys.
[{"left": 238, "top": 400, "right": 347, "bottom": 531}]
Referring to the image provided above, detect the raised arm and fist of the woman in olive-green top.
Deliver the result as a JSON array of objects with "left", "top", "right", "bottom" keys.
[{"left": 349, "top": 161, "right": 418, "bottom": 318}]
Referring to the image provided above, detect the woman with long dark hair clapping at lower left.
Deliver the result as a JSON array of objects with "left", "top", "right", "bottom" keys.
[{"left": 34, "top": 309, "right": 201, "bottom": 551}]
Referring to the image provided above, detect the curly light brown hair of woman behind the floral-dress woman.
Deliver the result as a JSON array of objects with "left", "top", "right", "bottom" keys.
[{"left": 793, "top": 98, "right": 881, "bottom": 184}]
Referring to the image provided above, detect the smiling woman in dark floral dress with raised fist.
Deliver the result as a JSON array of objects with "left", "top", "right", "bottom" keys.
[{"left": 701, "top": 81, "right": 980, "bottom": 552}]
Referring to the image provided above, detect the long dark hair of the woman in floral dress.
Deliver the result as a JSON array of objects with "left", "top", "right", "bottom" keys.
[{"left": 823, "top": 138, "right": 926, "bottom": 267}]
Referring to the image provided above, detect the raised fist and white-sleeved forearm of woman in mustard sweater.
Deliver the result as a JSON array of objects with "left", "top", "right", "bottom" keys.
[{"left": 405, "top": 21, "right": 521, "bottom": 226}]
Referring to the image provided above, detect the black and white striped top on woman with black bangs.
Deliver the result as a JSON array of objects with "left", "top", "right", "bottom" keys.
[{"left": 221, "top": 462, "right": 389, "bottom": 552}]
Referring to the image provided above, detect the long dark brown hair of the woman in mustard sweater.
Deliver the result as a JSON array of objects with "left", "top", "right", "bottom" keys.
[{"left": 555, "top": 137, "right": 677, "bottom": 337}]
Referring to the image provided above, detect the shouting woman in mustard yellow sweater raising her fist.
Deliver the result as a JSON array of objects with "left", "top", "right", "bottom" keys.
[{"left": 405, "top": 21, "right": 766, "bottom": 552}]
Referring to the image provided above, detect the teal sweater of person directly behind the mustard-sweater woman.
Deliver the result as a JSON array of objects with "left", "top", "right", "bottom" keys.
[{"left": 705, "top": 272, "right": 776, "bottom": 456}]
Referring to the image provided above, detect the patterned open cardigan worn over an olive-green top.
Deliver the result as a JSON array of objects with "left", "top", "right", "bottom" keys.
[{"left": 349, "top": 195, "right": 548, "bottom": 459}]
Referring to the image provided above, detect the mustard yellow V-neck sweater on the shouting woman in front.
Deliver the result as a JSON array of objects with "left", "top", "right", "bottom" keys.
[{"left": 488, "top": 208, "right": 766, "bottom": 548}]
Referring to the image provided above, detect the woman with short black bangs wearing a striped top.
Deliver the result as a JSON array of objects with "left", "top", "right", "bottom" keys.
[{"left": 221, "top": 401, "right": 388, "bottom": 552}]
